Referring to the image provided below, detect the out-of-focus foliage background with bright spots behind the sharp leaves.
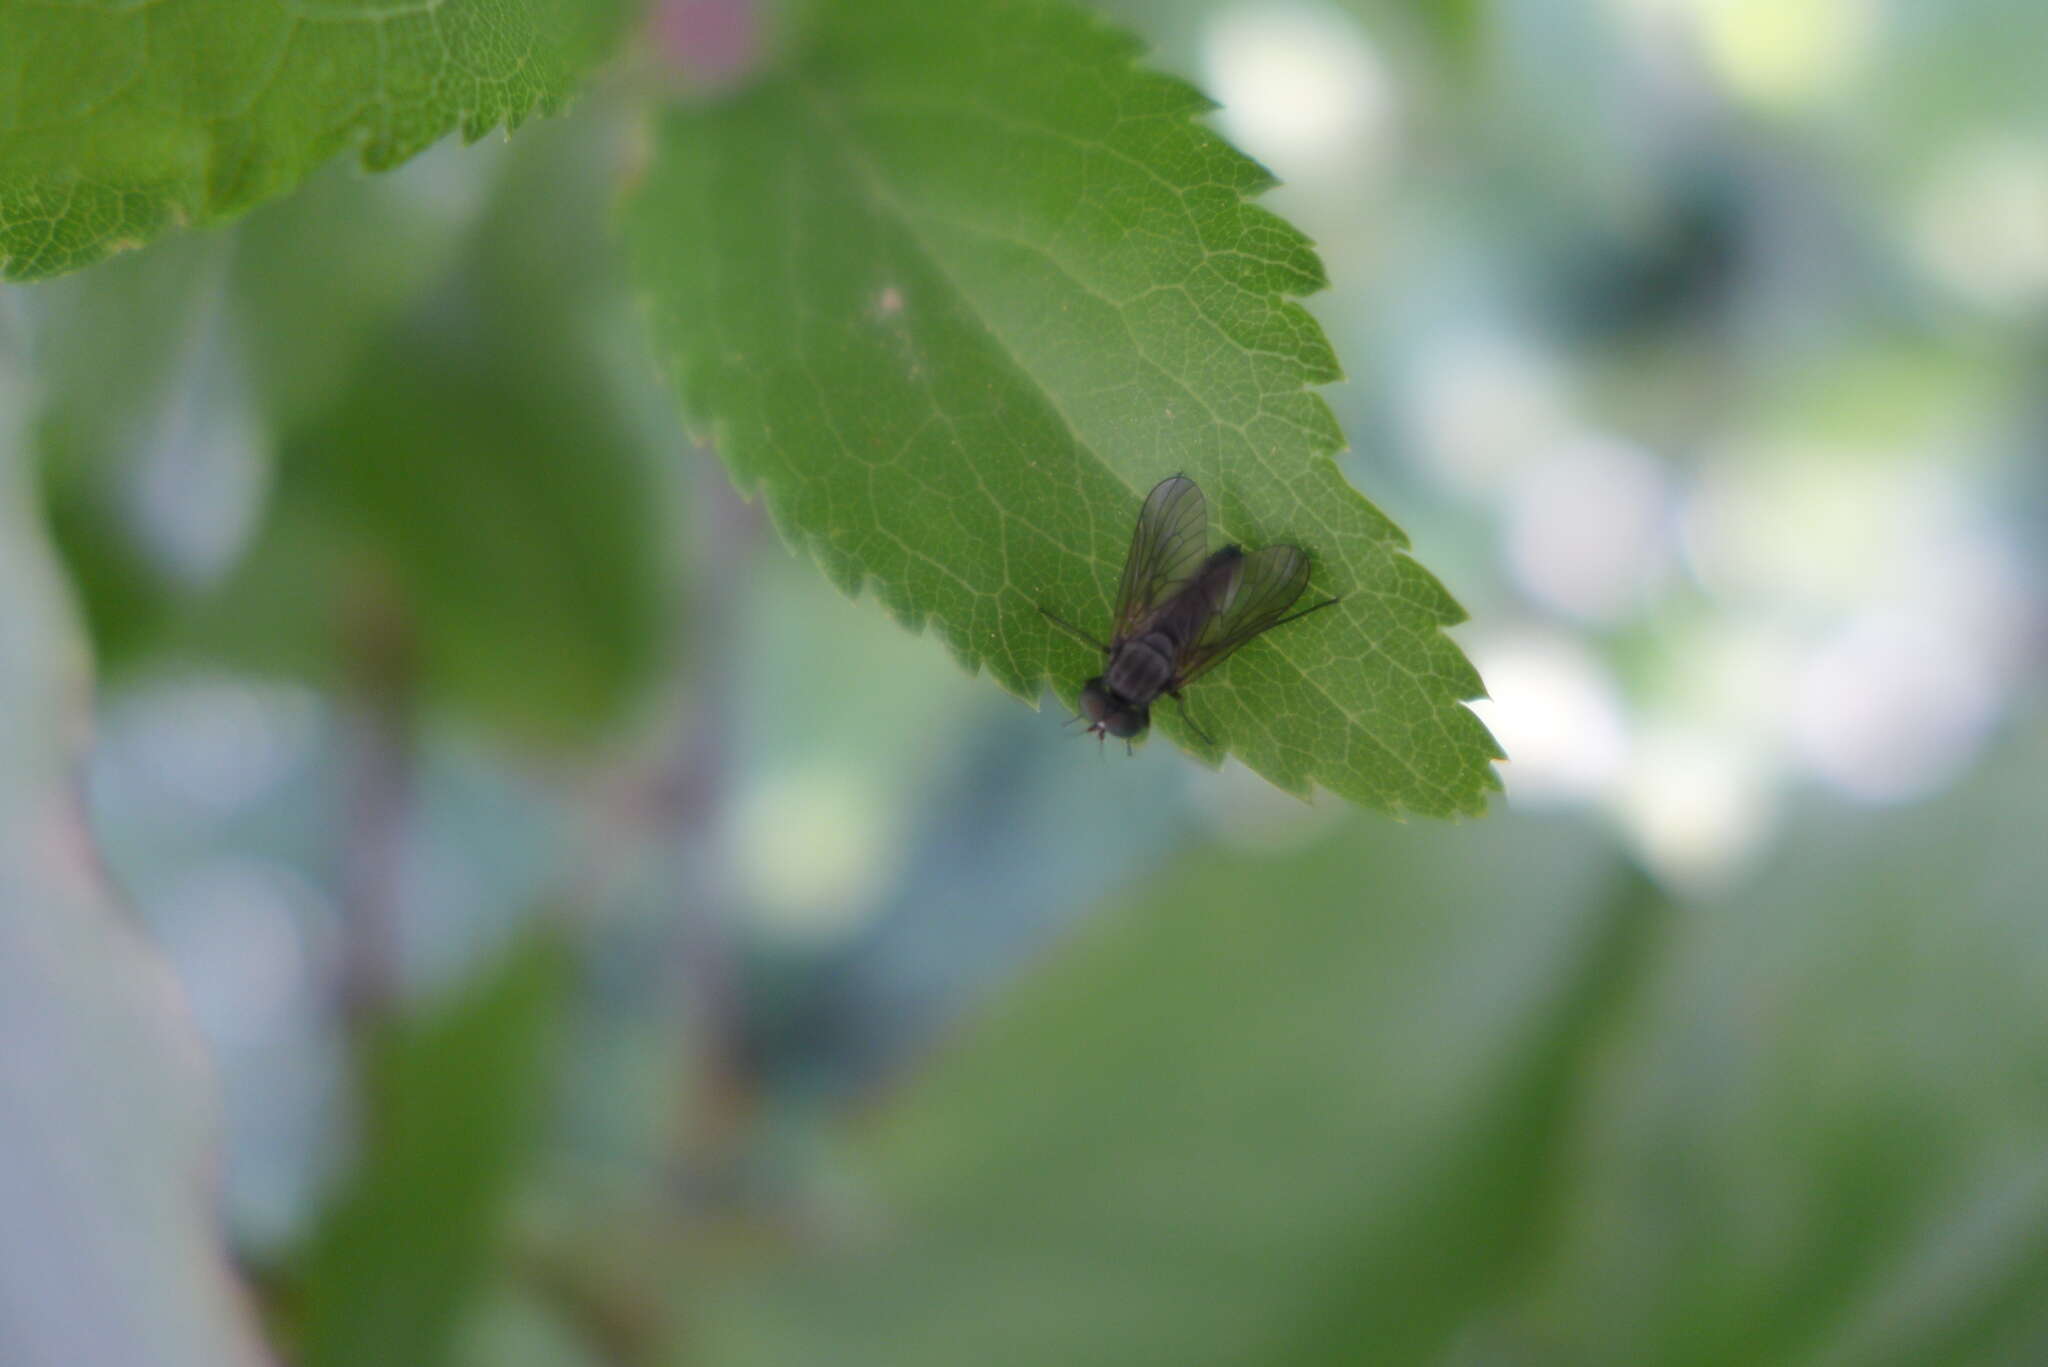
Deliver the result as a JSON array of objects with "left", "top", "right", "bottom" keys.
[{"left": 0, "top": 0, "right": 2048, "bottom": 1365}]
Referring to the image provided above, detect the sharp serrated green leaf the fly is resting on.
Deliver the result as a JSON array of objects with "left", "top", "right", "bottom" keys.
[{"left": 629, "top": 0, "right": 1499, "bottom": 814}]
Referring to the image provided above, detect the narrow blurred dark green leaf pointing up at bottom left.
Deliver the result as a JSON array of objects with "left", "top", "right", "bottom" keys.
[{"left": 303, "top": 933, "right": 569, "bottom": 1367}]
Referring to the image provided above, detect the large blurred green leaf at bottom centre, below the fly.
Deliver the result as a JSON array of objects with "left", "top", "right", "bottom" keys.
[{"left": 711, "top": 820, "right": 1661, "bottom": 1367}]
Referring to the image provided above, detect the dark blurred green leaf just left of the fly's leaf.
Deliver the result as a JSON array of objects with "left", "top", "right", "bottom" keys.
[{"left": 166, "top": 119, "right": 668, "bottom": 742}]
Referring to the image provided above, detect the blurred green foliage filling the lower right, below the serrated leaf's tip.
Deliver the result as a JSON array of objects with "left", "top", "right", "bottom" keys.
[{"left": 707, "top": 723, "right": 2048, "bottom": 1367}]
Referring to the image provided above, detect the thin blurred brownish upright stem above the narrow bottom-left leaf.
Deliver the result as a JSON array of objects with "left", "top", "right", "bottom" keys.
[{"left": 340, "top": 568, "right": 418, "bottom": 1045}]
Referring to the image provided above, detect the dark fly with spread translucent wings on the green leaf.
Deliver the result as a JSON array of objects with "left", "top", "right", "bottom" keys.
[{"left": 1038, "top": 475, "right": 1335, "bottom": 744}]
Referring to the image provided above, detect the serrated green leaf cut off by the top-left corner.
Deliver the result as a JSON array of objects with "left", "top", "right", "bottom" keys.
[{"left": 0, "top": 0, "right": 625, "bottom": 281}]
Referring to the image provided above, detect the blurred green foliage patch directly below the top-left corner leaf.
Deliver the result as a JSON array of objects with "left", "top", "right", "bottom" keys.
[{"left": 35, "top": 119, "right": 666, "bottom": 744}]
